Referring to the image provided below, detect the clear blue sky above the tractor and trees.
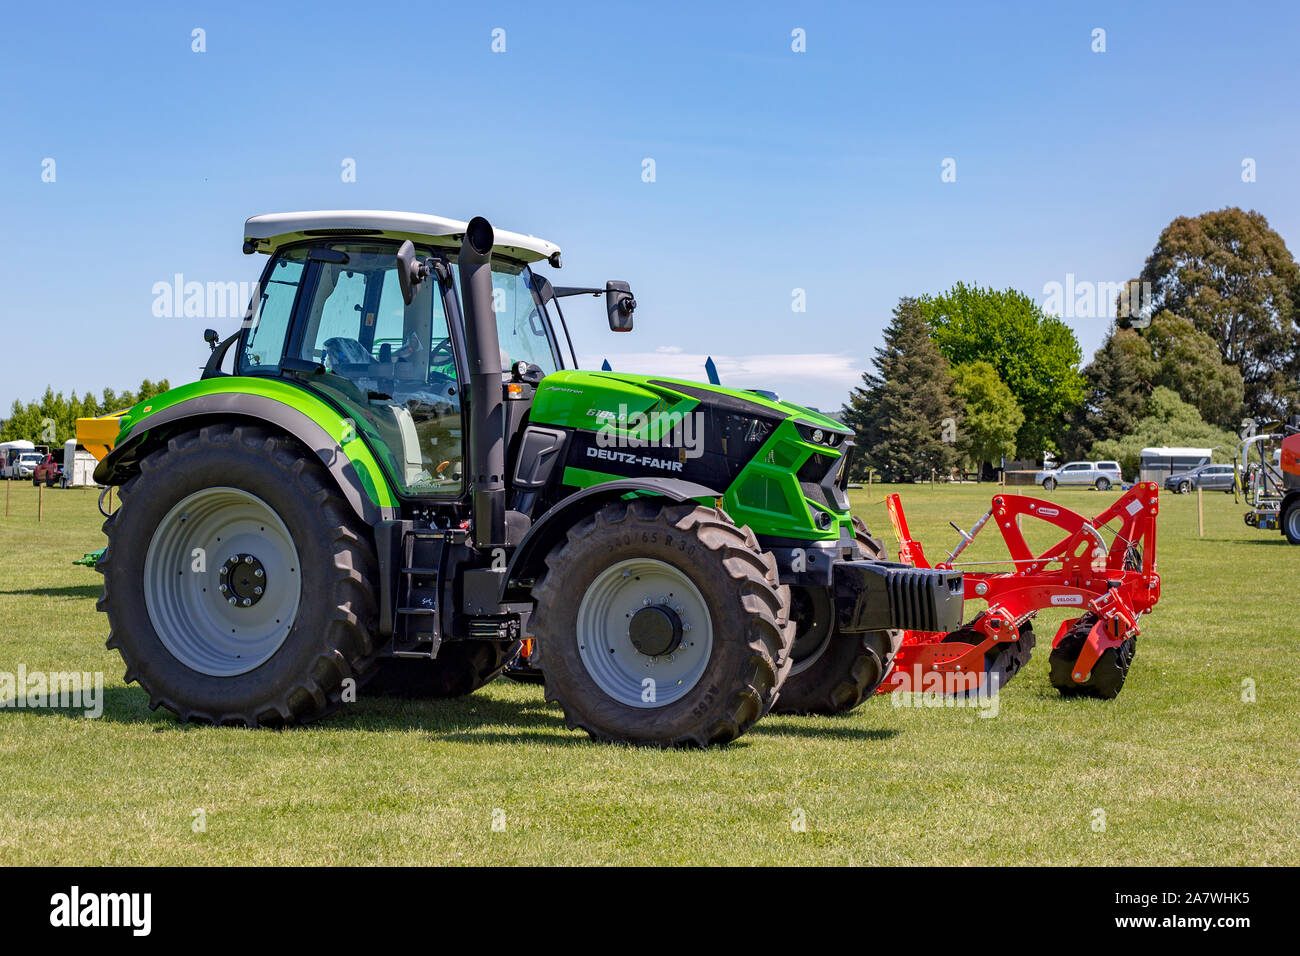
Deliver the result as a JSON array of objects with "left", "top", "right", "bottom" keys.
[{"left": 0, "top": 3, "right": 1300, "bottom": 414}]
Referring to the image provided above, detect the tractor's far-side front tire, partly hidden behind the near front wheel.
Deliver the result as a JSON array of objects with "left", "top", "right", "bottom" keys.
[{"left": 772, "top": 518, "right": 902, "bottom": 714}]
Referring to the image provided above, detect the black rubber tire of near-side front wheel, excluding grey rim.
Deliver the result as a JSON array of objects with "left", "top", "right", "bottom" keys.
[{"left": 532, "top": 498, "right": 794, "bottom": 747}]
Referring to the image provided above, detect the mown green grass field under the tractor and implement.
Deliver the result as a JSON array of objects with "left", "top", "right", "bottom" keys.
[{"left": 0, "top": 483, "right": 1300, "bottom": 865}]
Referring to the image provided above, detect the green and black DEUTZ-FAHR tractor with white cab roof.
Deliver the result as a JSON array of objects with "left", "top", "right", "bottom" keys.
[{"left": 95, "top": 212, "right": 962, "bottom": 745}]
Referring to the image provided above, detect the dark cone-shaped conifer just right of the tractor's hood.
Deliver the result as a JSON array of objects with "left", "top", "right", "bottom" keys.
[{"left": 844, "top": 298, "right": 961, "bottom": 481}]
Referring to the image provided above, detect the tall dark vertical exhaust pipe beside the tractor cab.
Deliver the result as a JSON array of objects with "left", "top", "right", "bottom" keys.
[{"left": 456, "top": 216, "right": 507, "bottom": 548}]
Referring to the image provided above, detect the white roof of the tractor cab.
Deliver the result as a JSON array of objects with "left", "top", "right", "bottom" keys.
[{"left": 244, "top": 209, "right": 560, "bottom": 263}]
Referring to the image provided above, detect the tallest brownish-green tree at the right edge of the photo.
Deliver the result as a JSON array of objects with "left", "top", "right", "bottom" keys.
[{"left": 1140, "top": 207, "right": 1300, "bottom": 418}]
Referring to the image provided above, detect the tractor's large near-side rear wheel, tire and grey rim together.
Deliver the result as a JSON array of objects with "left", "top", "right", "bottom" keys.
[{"left": 96, "top": 424, "right": 377, "bottom": 727}]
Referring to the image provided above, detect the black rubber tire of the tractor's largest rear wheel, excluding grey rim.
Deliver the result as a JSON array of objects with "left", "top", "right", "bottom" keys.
[{"left": 96, "top": 425, "right": 378, "bottom": 727}]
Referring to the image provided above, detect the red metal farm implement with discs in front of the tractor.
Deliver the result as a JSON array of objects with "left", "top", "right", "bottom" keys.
[{"left": 879, "top": 483, "right": 1160, "bottom": 697}]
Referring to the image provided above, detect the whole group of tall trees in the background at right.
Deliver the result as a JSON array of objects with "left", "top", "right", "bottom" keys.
[{"left": 841, "top": 207, "right": 1300, "bottom": 481}]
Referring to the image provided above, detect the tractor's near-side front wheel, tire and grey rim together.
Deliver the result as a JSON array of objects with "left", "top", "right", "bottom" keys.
[{"left": 532, "top": 498, "right": 793, "bottom": 747}]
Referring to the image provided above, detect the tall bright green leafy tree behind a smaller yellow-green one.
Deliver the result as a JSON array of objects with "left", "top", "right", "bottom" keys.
[{"left": 920, "top": 282, "right": 1083, "bottom": 458}]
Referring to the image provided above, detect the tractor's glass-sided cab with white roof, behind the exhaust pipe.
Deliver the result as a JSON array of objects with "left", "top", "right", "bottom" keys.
[{"left": 226, "top": 212, "right": 587, "bottom": 498}]
